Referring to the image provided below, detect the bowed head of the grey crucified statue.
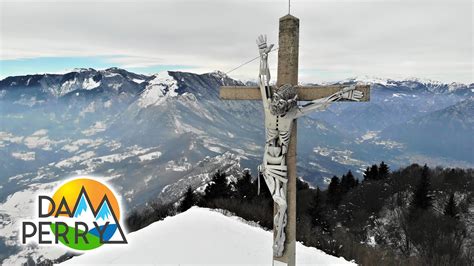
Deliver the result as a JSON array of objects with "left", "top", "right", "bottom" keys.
[{"left": 270, "top": 84, "right": 298, "bottom": 115}]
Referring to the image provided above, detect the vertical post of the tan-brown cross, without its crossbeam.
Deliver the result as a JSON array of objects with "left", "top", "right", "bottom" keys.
[{"left": 273, "top": 14, "right": 300, "bottom": 266}]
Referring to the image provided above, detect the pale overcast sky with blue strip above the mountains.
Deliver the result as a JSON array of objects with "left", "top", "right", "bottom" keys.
[{"left": 0, "top": 0, "right": 474, "bottom": 83}]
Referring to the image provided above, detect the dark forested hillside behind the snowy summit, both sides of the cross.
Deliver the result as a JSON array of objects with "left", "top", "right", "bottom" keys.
[{"left": 127, "top": 162, "right": 474, "bottom": 265}]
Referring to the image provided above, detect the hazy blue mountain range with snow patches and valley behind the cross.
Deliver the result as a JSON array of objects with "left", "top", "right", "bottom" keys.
[{"left": 0, "top": 68, "right": 474, "bottom": 264}]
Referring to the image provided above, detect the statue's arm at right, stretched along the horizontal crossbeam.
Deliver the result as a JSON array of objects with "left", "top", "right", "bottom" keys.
[{"left": 296, "top": 85, "right": 364, "bottom": 117}]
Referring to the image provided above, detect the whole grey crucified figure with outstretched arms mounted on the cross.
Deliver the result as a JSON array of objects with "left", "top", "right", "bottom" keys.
[{"left": 257, "top": 35, "right": 364, "bottom": 257}]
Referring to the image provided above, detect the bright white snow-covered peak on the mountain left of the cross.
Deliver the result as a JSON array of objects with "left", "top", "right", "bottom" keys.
[{"left": 138, "top": 71, "right": 178, "bottom": 108}]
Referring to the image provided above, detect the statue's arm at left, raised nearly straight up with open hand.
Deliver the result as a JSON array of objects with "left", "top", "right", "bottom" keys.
[{"left": 257, "top": 35, "right": 273, "bottom": 105}]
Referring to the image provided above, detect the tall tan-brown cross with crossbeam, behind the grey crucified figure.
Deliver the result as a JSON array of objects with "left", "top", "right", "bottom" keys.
[{"left": 220, "top": 14, "right": 370, "bottom": 266}]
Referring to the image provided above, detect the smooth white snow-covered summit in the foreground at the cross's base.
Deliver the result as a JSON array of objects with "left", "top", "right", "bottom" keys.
[{"left": 64, "top": 207, "right": 355, "bottom": 265}]
